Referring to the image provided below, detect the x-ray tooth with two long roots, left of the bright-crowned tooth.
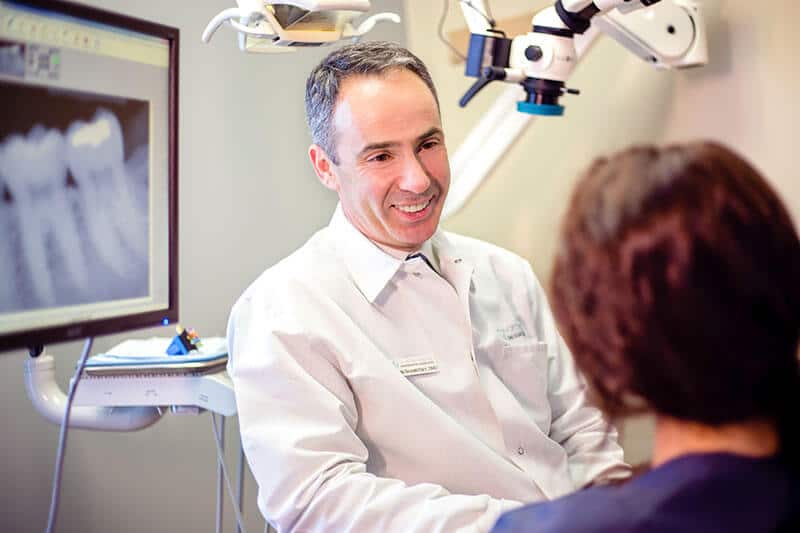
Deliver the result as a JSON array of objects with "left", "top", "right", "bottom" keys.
[{"left": 0, "top": 125, "right": 89, "bottom": 305}]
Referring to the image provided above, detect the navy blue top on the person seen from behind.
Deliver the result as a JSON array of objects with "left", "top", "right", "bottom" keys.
[{"left": 492, "top": 453, "right": 800, "bottom": 533}]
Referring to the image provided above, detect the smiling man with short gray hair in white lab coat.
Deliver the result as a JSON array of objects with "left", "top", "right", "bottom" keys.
[{"left": 228, "top": 42, "right": 628, "bottom": 533}]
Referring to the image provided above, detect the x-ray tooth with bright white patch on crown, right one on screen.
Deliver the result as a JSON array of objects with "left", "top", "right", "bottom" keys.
[{"left": 66, "top": 109, "right": 148, "bottom": 277}]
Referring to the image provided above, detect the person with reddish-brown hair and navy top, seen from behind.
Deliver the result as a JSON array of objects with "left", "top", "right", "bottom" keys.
[{"left": 493, "top": 142, "right": 800, "bottom": 533}]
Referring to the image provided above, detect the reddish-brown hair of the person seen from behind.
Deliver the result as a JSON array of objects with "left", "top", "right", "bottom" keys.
[{"left": 551, "top": 142, "right": 800, "bottom": 458}]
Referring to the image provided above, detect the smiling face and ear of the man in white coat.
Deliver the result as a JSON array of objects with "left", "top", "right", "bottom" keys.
[{"left": 309, "top": 69, "right": 450, "bottom": 251}]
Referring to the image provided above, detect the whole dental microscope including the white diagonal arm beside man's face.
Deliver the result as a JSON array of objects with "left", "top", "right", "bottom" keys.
[{"left": 442, "top": 0, "right": 708, "bottom": 220}]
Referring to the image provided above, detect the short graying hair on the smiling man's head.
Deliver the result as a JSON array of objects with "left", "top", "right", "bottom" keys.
[{"left": 306, "top": 41, "right": 439, "bottom": 164}]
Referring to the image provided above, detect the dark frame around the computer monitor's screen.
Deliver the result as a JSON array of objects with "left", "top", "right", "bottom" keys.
[{"left": 0, "top": 0, "right": 180, "bottom": 352}]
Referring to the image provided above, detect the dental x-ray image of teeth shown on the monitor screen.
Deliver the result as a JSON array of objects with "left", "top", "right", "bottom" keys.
[{"left": 0, "top": 82, "right": 150, "bottom": 312}]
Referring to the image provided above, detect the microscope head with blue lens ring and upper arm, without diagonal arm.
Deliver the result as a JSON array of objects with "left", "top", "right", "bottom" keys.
[{"left": 459, "top": 0, "right": 707, "bottom": 115}]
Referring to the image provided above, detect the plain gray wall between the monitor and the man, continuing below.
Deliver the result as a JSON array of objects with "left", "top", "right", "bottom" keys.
[{"left": 0, "top": 0, "right": 404, "bottom": 533}]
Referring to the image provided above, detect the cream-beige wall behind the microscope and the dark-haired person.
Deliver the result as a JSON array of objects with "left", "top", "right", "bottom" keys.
[{"left": 405, "top": 0, "right": 800, "bottom": 462}]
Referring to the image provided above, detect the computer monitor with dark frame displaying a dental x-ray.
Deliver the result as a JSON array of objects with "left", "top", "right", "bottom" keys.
[{"left": 0, "top": 0, "right": 179, "bottom": 351}]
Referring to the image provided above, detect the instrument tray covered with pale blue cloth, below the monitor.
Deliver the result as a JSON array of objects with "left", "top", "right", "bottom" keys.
[{"left": 83, "top": 337, "right": 228, "bottom": 377}]
